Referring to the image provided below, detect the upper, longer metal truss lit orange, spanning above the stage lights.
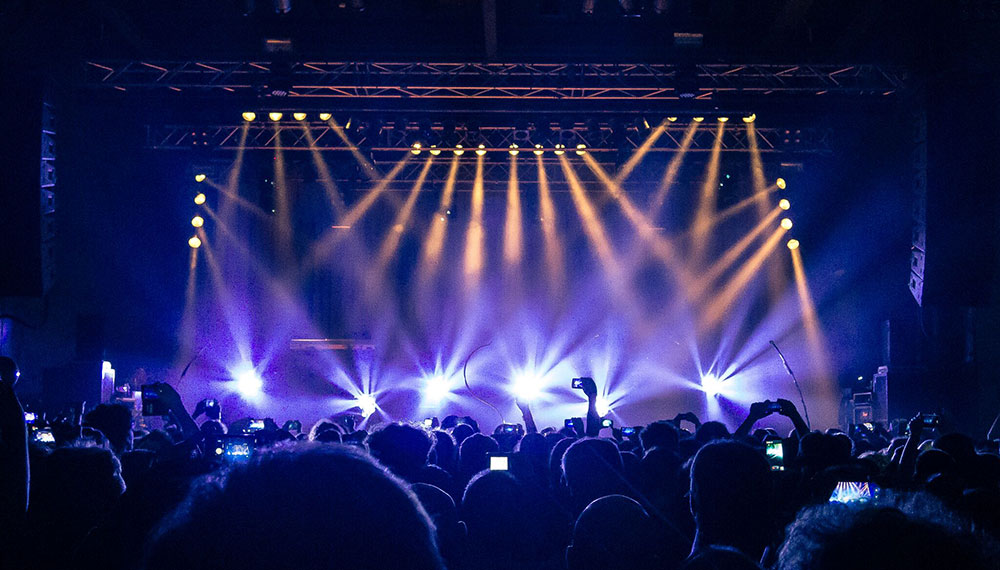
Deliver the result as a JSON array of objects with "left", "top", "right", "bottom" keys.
[{"left": 82, "top": 61, "right": 906, "bottom": 101}]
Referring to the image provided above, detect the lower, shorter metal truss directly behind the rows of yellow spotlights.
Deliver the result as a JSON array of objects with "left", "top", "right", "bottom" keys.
[{"left": 147, "top": 119, "right": 833, "bottom": 157}]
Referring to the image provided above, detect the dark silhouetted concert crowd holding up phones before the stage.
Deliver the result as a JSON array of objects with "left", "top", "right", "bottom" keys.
[{"left": 0, "top": 359, "right": 1000, "bottom": 570}]
